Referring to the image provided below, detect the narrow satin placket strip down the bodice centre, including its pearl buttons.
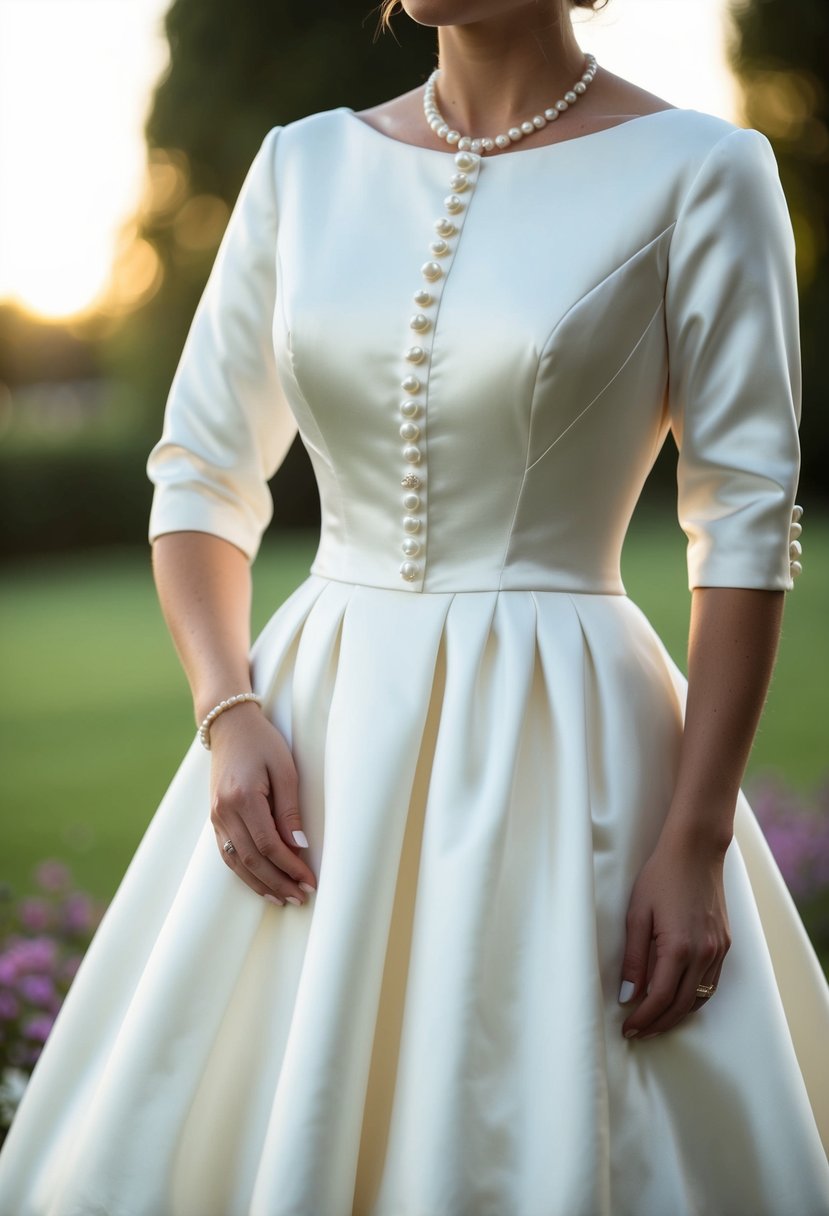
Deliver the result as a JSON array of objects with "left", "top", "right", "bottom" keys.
[{"left": 397, "top": 152, "right": 481, "bottom": 591}]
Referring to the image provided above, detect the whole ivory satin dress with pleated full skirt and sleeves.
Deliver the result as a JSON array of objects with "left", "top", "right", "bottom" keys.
[{"left": 0, "top": 107, "right": 829, "bottom": 1216}]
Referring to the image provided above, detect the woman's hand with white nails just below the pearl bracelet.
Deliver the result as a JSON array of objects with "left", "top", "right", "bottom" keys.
[{"left": 210, "top": 702, "right": 316, "bottom": 903}]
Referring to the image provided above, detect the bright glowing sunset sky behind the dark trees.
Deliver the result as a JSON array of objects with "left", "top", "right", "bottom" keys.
[{"left": 0, "top": 0, "right": 737, "bottom": 317}]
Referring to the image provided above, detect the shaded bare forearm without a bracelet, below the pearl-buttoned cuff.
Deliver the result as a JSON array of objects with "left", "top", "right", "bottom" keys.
[{"left": 662, "top": 587, "right": 785, "bottom": 851}]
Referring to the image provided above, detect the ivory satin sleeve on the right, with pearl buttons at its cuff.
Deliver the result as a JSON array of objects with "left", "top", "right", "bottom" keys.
[{"left": 665, "top": 128, "right": 801, "bottom": 590}]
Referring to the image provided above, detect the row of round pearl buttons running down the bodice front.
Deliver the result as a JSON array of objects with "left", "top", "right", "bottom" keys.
[{"left": 400, "top": 152, "right": 478, "bottom": 582}]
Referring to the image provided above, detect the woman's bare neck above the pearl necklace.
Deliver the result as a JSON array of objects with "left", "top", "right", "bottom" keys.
[{"left": 438, "top": 2, "right": 585, "bottom": 135}]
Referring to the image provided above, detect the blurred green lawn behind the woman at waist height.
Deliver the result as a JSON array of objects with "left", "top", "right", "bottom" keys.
[{"left": 0, "top": 513, "right": 829, "bottom": 899}]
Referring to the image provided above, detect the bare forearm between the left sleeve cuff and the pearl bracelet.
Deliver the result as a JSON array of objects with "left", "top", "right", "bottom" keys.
[{"left": 153, "top": 531, "right": 250, "bottom": 721}]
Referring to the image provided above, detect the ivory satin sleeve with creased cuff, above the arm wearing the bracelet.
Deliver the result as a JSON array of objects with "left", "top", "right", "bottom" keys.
[{"left": 147, "top": 126, "right": 297, "bottom": 561}]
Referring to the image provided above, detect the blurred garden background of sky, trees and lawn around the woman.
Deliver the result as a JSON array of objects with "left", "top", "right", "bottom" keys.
[{"left": 0, "top": 0, "right": 829, "bottom": 1100}]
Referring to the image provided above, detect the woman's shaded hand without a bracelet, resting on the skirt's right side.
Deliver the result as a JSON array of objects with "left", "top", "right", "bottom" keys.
[{"left": 612, "top": 837, "right": 731, "bottom": 1038}]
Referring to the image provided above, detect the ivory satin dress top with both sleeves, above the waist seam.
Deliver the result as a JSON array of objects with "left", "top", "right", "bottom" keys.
[{"left": 148, "top": 107, "right": 800, "bottom": 593}]
